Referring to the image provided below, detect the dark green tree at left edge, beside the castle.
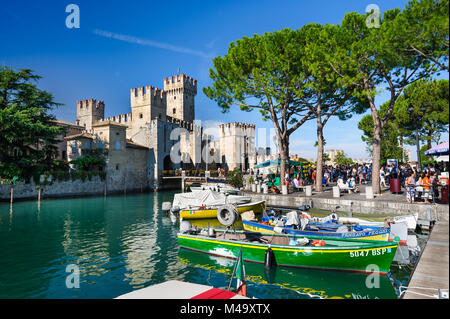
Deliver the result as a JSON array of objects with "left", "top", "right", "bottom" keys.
[{"left": 0, "top": 66, "right": 63, "bottom": 180}]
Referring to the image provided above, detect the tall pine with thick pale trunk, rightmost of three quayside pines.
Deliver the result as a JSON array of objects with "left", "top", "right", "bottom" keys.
[{"left": 327, "top": 0, "right": 448, "bottom": 194}]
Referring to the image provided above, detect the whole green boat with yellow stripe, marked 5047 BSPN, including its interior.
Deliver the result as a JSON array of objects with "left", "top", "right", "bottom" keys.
[{"left": 177, "top": 229, "right": 398, "bottom": 274}]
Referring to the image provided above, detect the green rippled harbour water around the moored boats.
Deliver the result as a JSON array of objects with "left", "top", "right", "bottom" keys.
[{"left": 0, "top": 192, "right": 410, "bottom": 298}]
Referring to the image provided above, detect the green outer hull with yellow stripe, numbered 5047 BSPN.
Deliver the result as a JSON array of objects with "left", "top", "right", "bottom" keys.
[{"left": 178, "top": 234, "right": 397, "bottom": 274}]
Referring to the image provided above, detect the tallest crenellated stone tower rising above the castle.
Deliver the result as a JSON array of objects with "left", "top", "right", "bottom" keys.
[{"left": 164, "top": 74, "right": 197, "bottom": 122}]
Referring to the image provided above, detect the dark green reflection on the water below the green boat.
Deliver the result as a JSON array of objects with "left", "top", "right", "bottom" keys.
[{"left": 178, "top": 249, "right": 397, "bottom": 299}]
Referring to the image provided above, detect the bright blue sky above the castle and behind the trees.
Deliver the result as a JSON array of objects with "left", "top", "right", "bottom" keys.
[{"left": 0, "top": 0, "right": 448, "bottom": 158}]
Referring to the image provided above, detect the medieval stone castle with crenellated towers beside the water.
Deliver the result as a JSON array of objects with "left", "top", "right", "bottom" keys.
[{"left": 60, "top": 74, "right": 264, "bottom": 191}]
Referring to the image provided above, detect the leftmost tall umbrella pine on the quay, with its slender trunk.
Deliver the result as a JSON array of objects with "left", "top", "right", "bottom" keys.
[{"left": 203, "top": 29, "right": 318, "bottom": 186}]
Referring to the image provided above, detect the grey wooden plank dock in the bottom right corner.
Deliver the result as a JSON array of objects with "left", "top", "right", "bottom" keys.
[{"left": 403, "top": 221, "right": 449, "bottom": 299}]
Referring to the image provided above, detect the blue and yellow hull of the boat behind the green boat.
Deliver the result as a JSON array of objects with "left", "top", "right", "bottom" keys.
[{"left": 242, "top": 220, "right": 390, "bottom": 241}]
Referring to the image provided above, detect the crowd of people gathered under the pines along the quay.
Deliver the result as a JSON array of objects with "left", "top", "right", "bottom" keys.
[{"left": 248, "top": 162, "right": 449, "bottom": 203}]
